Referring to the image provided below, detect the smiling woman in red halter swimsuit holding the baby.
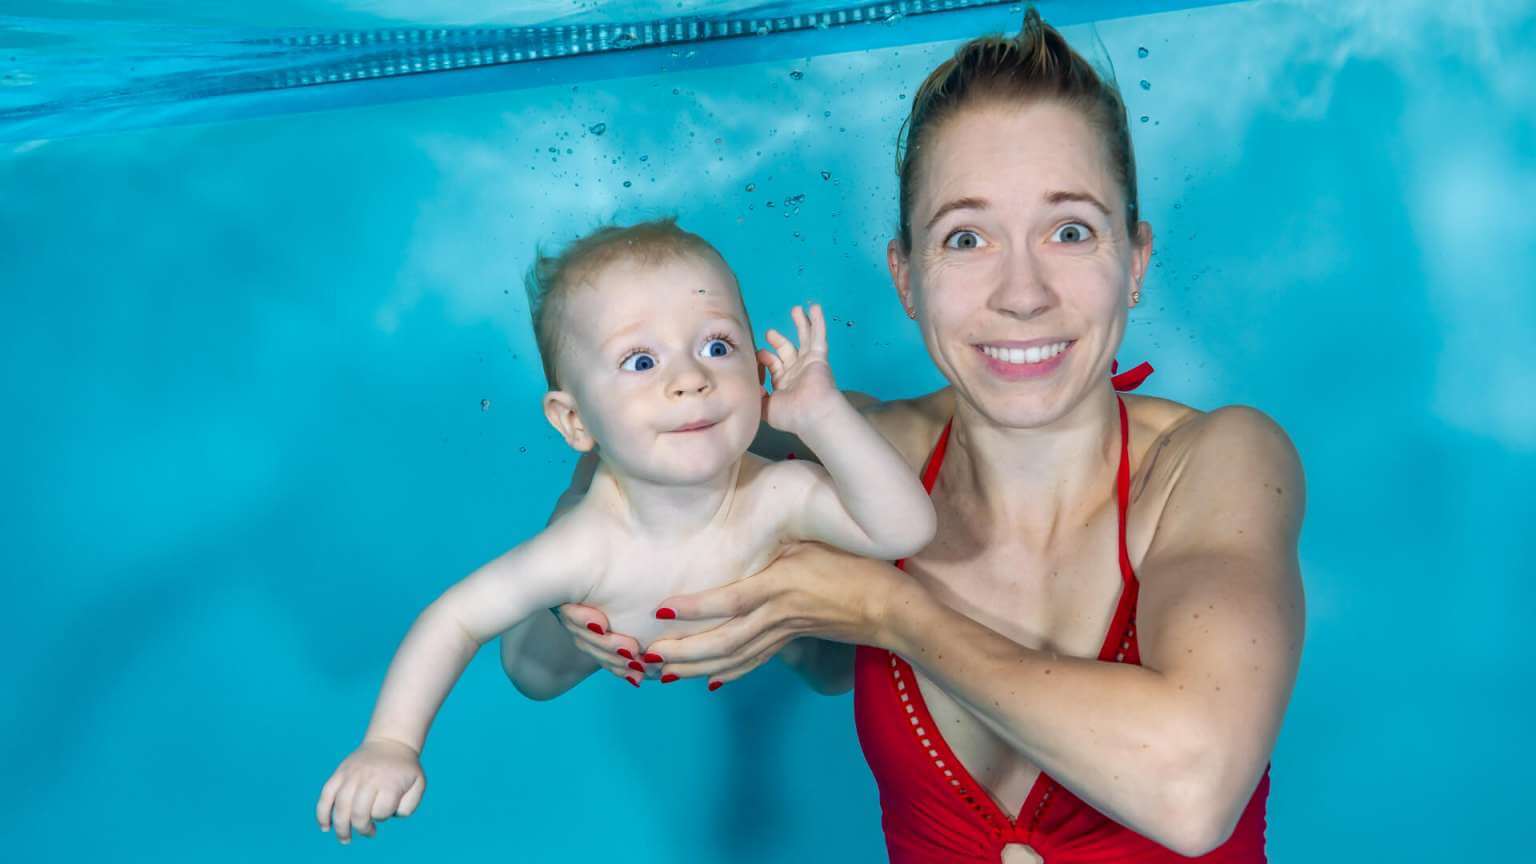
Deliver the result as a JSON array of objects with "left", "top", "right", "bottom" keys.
[{"left": 531, "top": 9, "right": 1304, "bottom": 864}]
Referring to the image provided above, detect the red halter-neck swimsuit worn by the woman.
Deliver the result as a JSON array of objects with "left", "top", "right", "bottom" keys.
[{"left": 854, "top": 363, "right": 1269, "bottom": 864}]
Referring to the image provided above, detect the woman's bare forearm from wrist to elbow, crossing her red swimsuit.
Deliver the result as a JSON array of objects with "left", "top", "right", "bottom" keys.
[{"left": 866, "top": 561, "right": 1221, "bottom": 853}]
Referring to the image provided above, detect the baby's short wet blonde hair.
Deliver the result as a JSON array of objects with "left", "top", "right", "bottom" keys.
[{"left": 524, "top": 217, "right": 745, "bottom": 390}]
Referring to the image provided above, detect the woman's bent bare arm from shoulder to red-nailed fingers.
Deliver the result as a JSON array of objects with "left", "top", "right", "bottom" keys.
[{"left": 651, "top": 409, "right": 1304, "bottom": 856}]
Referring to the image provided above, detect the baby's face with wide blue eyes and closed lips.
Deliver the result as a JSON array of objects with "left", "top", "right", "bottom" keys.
[{"left": 559, "top": 255, "right": 763, "bottom": 484}]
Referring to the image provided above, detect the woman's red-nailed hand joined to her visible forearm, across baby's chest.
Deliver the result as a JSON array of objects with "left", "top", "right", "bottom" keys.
[{"left": 645, "top": 543, "right": 919, "bottom": 690}]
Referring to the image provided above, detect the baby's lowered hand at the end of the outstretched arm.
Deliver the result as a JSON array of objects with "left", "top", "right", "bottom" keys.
[{"left": 315, "top": 739, "right": 427, "bottom": 842}]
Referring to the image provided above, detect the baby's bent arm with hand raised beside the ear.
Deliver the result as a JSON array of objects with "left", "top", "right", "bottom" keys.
[{"left": 759, "top": 306, "right": 935, "bottom": 558}]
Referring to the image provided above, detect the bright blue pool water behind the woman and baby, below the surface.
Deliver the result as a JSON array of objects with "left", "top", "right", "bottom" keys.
[{"left": 0, "top": 0, "right": 1536, "bottom": 864}]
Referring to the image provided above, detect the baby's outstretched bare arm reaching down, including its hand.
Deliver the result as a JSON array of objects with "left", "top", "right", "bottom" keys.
[{"left": 315, "top": 520, "right": 596, "bottom": 842}]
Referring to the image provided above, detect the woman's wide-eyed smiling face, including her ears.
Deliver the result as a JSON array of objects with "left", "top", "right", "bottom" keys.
[{"left": 889, "top": 101, "right": 1152, "bottom": 427}]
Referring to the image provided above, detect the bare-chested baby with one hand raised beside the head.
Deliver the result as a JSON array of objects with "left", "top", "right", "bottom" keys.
[{"left": 316, "top": 220, "right": 934, "bottom": 842}]
